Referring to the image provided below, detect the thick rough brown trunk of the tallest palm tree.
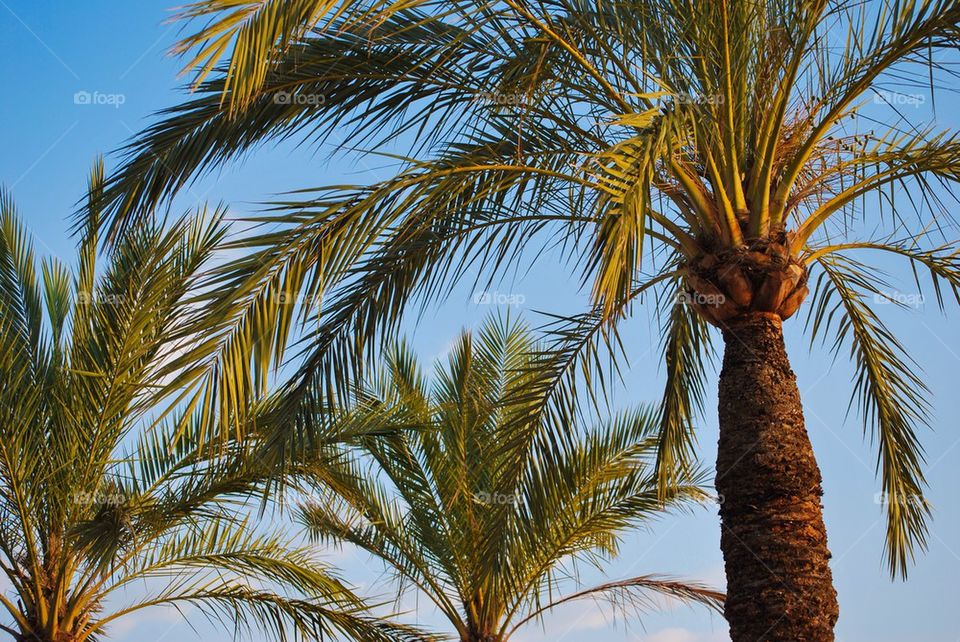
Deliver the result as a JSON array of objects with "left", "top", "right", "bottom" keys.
[{"left": 716, "top": 313, "right": 839, "bottom": 642}]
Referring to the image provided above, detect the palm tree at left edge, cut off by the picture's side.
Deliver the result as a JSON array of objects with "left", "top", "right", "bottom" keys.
[{"left": 0, "top": 166, "right": 430, "bottom": 642}]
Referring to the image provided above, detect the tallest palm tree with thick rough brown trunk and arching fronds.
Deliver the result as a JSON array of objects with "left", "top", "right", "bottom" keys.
[{"left": 99, "top": 0, "right": 960, "bottom": 642}]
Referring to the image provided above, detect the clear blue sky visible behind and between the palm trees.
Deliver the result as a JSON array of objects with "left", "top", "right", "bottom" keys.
[{"left": 0, "top": 0, "right": 960, "bottom": 642}]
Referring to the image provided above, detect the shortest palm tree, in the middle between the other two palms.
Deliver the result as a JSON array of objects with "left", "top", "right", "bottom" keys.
[{"left": 303, "top": 320, "right": 723, "bottom": 642}]
